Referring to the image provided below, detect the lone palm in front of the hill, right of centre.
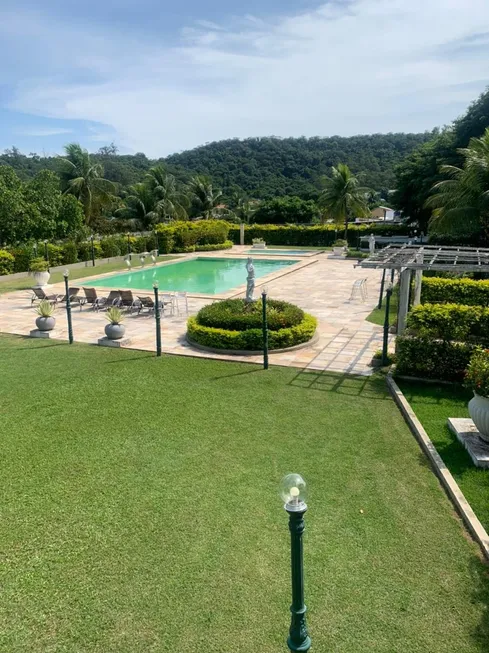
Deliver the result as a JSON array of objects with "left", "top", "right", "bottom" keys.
[{"left": 318, "top": 163, "right": 371, "bottom": 240}]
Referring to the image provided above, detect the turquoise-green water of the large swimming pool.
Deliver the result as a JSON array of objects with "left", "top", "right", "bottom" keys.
[{"left": 80, "top": 257, "right": 297, "bottom": 295}]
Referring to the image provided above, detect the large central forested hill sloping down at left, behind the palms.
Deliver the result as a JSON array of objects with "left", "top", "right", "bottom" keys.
[{"left": 166, "top": 132, "right": 432, "bottom": 199}]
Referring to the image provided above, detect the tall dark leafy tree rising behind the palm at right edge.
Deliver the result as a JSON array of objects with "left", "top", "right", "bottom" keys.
[{"left": 393, "top": 85, "right": 489, "bottom": 231}]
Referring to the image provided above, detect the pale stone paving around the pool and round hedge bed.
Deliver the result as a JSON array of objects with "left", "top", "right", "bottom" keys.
[{"left": 0, "top": 246, "right": 388, "bottom": 375}]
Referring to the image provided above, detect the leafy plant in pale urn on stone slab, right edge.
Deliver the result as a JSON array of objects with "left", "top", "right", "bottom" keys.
[{"left": 465, "top": 347, "right": 489, "bottom": 442}]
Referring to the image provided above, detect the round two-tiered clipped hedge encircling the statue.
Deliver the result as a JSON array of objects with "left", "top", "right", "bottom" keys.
[{"left": 187, "top": 299, "right": 317, "bottom": 351}]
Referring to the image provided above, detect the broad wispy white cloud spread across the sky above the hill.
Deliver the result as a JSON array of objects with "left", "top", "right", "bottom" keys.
[{"left": 0, "top": 0, "right": 489, "bottom": 156}]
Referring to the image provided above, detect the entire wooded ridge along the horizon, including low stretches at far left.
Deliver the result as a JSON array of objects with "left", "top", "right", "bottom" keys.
[{"left": 0, "top": 132, "right": 432, "bottom": 199}]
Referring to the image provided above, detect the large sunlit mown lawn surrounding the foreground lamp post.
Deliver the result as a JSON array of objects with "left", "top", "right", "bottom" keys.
[{"left": 0, "top": 336, "right": 489, "bottom": 653}]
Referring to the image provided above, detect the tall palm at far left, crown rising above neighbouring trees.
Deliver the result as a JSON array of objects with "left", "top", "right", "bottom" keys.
[{"left": 59, "top": 143, "right": 116, "bottom": 224}]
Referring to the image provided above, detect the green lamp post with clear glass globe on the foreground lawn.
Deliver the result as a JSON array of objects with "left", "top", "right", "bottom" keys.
[{"left": 280, "top": 474, "right": 311, "bottom": 651}]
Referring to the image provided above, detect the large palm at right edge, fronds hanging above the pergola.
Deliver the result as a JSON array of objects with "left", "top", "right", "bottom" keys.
[{"left": 426, "top": 128, "right": 489, "bottom": 235}]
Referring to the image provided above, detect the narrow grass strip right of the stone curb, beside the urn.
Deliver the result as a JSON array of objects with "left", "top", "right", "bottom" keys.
[{"left": 398, "top": 380, "right": 489, "bottom": 532}]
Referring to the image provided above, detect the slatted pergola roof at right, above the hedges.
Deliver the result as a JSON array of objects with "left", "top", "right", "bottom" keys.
[{"left": 359, "top": 243, "right": 489, "bottom": 272}]
